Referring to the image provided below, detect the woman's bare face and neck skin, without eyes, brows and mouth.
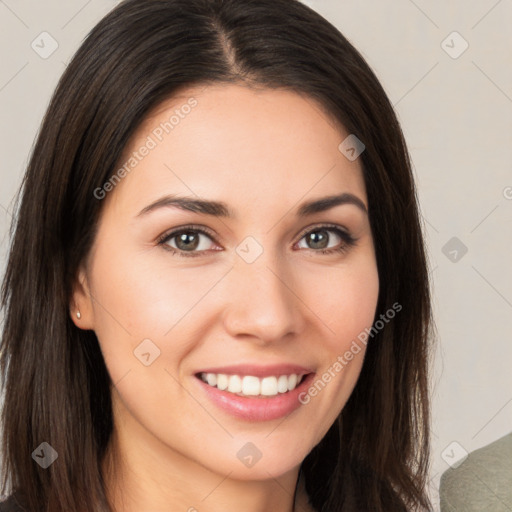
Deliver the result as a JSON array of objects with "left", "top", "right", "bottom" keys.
[{"left": 70, "top": 84, "right": 379, "bottom": 512}]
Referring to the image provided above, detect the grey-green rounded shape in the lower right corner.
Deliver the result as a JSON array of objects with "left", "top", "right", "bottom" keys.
[{"left": 440, "top": 432, "right": 512, "bottom": 512}]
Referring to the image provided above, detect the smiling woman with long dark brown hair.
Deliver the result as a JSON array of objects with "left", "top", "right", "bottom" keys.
[{"left": 0, "top": 0, "right": 431, "bottom": 512}]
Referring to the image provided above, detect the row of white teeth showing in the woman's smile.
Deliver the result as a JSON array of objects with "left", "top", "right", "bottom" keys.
[{"left": 201, "top": 373, "right": 304, "bottom": 396}]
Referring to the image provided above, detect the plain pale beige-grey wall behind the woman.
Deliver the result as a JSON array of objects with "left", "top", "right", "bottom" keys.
[{"left": 0, "top": 0, "right": 512, "bottom": 508}]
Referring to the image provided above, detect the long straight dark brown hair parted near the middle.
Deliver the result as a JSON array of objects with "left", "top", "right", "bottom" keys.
[{"left": 0, "top": 0, "right": 433, "bottom": 512}]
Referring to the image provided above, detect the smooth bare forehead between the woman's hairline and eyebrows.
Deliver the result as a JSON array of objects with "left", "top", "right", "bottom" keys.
[{"left": 105, "top": 84, "right": 366, "bottom": 215}]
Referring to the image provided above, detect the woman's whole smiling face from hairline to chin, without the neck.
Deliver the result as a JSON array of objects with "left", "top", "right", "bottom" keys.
[{"left": 73, "top": 85, "right": 379, "bottom": 480}]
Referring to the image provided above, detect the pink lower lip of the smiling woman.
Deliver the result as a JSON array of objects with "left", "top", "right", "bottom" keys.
[{"left": 194, "top": 373, "right": 315, "bottom": 421}]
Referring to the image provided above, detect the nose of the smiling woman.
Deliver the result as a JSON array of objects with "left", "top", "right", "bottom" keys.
[{"left": 219, "top": 248, "right": 305, "bottom": 345}]
